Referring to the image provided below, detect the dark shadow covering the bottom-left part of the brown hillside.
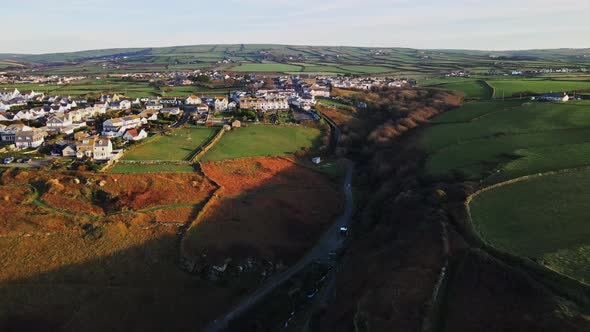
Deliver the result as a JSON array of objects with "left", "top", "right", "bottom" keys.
[{"left": 0, "top": 234, "right": 243, "bottom": 331}]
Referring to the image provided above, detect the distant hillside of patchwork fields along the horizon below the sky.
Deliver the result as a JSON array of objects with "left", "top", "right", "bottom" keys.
[{"left": 0, "top": 44, "right": 590, "bottom": 74}]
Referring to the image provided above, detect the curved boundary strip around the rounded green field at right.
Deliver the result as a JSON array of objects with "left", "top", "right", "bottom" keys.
[{"left": 456, "top": 166, "right": 590, "bottom": 306}]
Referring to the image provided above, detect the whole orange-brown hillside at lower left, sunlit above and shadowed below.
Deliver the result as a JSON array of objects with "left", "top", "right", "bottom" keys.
[{"left": 0, "top": 170, "right": 242, "bottom": 331}]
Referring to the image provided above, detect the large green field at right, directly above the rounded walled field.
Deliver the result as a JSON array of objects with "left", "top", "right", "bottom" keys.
[{"left": 419, "top": 101, "right": 590, "bottom": 183}]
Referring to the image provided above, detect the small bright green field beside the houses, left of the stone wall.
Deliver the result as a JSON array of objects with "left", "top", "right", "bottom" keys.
[{"left": 122, "top": 127, "right": 218, "bottom": 160}]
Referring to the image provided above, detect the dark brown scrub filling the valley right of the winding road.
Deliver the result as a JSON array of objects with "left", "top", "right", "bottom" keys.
[{"left": 313, "top": 89, "right": 589, "bottom": 331}]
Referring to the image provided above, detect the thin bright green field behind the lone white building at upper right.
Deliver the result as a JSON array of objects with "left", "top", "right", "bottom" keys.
[{"left": 487, "top": 79, "right": 590, "bottom": 98}]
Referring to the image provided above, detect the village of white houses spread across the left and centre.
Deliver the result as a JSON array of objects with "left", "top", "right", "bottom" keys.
[{"left": 0, "top": 74, "right": 413, "bottom": 161}]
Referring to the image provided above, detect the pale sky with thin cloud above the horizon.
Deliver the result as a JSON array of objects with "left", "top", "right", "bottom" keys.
[{"left": 0, "top": 0, "right": 590, "bottom": 54}]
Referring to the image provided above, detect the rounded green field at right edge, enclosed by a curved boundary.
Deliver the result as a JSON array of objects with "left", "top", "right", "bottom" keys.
[{"left": 470, "top": 171, "right": 590, "bottom": 283}]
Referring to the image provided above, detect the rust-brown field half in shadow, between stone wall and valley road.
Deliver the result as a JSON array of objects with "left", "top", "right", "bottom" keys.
[{"left": 183, "top": 157, "right": 344, "bottom": 264}]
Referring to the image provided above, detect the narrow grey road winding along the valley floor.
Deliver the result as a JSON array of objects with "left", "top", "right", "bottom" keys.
[{"left": 203, "top": 160, "right": 354, "bottom": 332}]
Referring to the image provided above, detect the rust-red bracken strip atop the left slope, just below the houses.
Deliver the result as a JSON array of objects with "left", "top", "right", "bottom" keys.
[{"left": 2, "top": 171, "right": 215, "bottom": 222}]
